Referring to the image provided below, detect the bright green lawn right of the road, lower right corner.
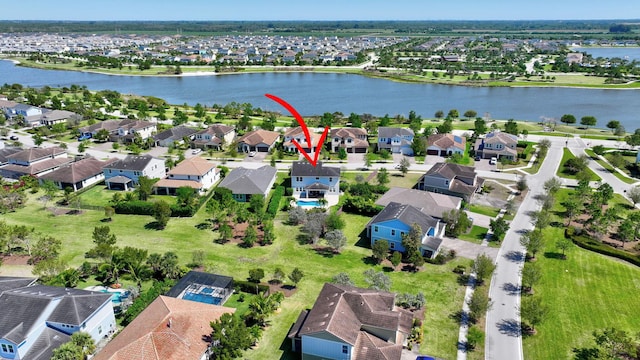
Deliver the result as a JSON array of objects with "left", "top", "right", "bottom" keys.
[{"left": 523, "top": 228, "right": 640, "bottom": 360}]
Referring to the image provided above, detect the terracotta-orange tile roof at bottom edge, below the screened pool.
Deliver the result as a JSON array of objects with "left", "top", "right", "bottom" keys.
[{"left": 93, "top": 295, "right": 235, "bottom": 360}]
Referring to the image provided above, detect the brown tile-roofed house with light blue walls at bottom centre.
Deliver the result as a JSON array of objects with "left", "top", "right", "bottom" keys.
[{"left": 288, "top": 283, "right": 413, "bottom": 360}]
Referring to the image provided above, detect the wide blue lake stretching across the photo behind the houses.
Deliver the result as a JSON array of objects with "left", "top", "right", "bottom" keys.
[{"left": 0, "top": 61, "right": 640, "bottom": 130}]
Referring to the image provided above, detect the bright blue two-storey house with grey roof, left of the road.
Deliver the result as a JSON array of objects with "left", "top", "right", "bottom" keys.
[{"left": 367, "top": 202, "right": 445, "bottom": 258}]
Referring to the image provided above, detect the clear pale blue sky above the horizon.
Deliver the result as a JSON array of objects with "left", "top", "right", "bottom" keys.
[{"left": 0, "top": 0, "right": 640, "bottom": 21}]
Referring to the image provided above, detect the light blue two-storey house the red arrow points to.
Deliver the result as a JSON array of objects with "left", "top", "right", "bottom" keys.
[{"left": 291, "top": 161, "right": 340, "bottom": 201}]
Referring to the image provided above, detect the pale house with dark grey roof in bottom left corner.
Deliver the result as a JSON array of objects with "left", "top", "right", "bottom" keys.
[{"left": 0, "top": 277, "right": 116, "bottom": 360}]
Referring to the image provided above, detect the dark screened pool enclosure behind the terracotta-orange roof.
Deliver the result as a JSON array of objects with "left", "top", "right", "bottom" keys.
[{"left": 165, "top": 270, "right": 233, "bottom": 305}]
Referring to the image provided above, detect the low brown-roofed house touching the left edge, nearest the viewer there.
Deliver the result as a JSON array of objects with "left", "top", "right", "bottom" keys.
[{"left": 0, "top": 146, "right": 73, "bottom": 179}]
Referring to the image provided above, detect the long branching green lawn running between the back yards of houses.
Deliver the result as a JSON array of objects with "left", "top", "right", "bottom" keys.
[{"left": 3, "top": 193, "right": 468, "bottom": 360}]
